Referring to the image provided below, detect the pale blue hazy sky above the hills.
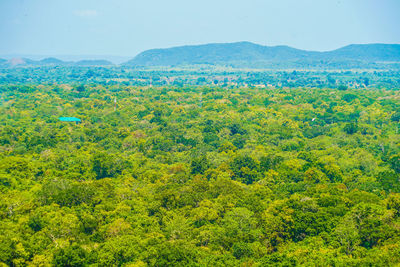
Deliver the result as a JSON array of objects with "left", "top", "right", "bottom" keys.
[{"left": 0, "top": 0, "right": 400, "bottom": 56}]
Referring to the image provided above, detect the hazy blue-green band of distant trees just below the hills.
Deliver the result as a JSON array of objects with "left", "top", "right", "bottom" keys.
[{"left": 0, "top": 66, "right": 400, "bottom": 89}]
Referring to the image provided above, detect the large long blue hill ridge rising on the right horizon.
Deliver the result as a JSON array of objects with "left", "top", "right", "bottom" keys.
[{"left": 125, "top": 42, "right": 400, "bottom": 68}]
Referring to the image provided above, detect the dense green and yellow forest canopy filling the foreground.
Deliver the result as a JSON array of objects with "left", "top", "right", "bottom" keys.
[{"left": 0, "top": 82, "right": 400, "bottom": 266}]
